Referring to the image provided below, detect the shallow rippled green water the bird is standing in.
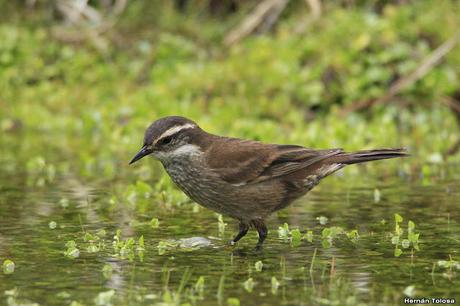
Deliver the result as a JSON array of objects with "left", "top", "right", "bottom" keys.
[{"left": 0, "top": 161, "right": 460, "bottom": 305}]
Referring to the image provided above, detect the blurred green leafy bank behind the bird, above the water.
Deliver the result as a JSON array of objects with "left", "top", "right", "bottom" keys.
[{"left": 0, "top": 0, "right": 460, "bottom": 176}]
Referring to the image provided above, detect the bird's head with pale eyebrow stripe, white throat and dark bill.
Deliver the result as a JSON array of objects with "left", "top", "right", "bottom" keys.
[{"left": 129, "top": 116, "right": 204, "bottom": 164}]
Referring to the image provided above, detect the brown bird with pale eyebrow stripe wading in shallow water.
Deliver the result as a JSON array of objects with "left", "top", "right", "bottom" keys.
[{"left": 130, "top": 116, "right": 408, "bottom": 248}]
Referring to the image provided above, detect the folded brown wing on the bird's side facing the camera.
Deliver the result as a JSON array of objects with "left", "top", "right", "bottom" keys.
[{"left": 206, "top": 139, "right": 342, "bottom": 185}]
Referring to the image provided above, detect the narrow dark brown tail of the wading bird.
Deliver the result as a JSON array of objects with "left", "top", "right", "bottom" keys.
[{"left": 330, "top": 148, "right": 409, "bottom": 165}]
